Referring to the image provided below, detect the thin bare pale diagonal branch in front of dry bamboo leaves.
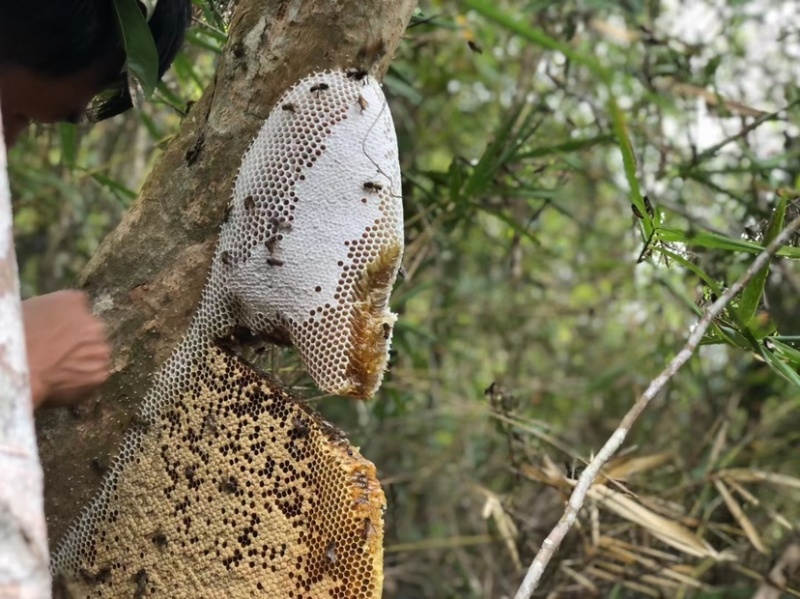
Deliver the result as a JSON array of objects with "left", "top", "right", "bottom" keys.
[{"left": 514, "top": 216, "right": 800, "bottom": 599}]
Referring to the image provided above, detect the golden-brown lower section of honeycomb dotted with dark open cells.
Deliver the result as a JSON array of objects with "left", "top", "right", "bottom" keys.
[{"left": 53, "top": 344, "right": 384, "bottom": 599}]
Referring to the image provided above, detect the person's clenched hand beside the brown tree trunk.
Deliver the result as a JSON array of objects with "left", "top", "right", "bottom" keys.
[{"left": 22, "top": 291, "right": 111, "bottom": 408}]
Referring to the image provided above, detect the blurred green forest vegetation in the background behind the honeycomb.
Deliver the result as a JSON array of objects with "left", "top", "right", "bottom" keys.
[{"left": 10, "top": 0, "right": 800, "bottom": 599}]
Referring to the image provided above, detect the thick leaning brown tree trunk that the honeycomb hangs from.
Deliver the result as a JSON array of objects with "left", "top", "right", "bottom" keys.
[{"left": 38, "top": 0, "right": 416, "bottom": 544}]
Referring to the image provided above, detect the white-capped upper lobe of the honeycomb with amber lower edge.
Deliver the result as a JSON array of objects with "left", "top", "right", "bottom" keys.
[{"left": 216, "top": 71, "right": 403, "bottom": 399}]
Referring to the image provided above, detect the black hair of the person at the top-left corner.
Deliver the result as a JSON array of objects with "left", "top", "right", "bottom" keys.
[{"left": 0, "top": 0, "right": 191, "bottom": 121}]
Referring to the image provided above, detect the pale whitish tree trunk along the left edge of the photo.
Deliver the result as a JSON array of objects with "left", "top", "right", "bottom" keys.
[{"left": 0, "top": 109, "right": 50, "bottom": 599}]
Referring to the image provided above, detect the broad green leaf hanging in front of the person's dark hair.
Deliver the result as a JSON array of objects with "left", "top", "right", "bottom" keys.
[{"left": 114, "top": 0, "right": 158, "bottom": 104}]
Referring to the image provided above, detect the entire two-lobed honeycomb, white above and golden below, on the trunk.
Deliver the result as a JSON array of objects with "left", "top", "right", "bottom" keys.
[{"left": 51, "top": 70, "right": 403, "bottom": 599}]
